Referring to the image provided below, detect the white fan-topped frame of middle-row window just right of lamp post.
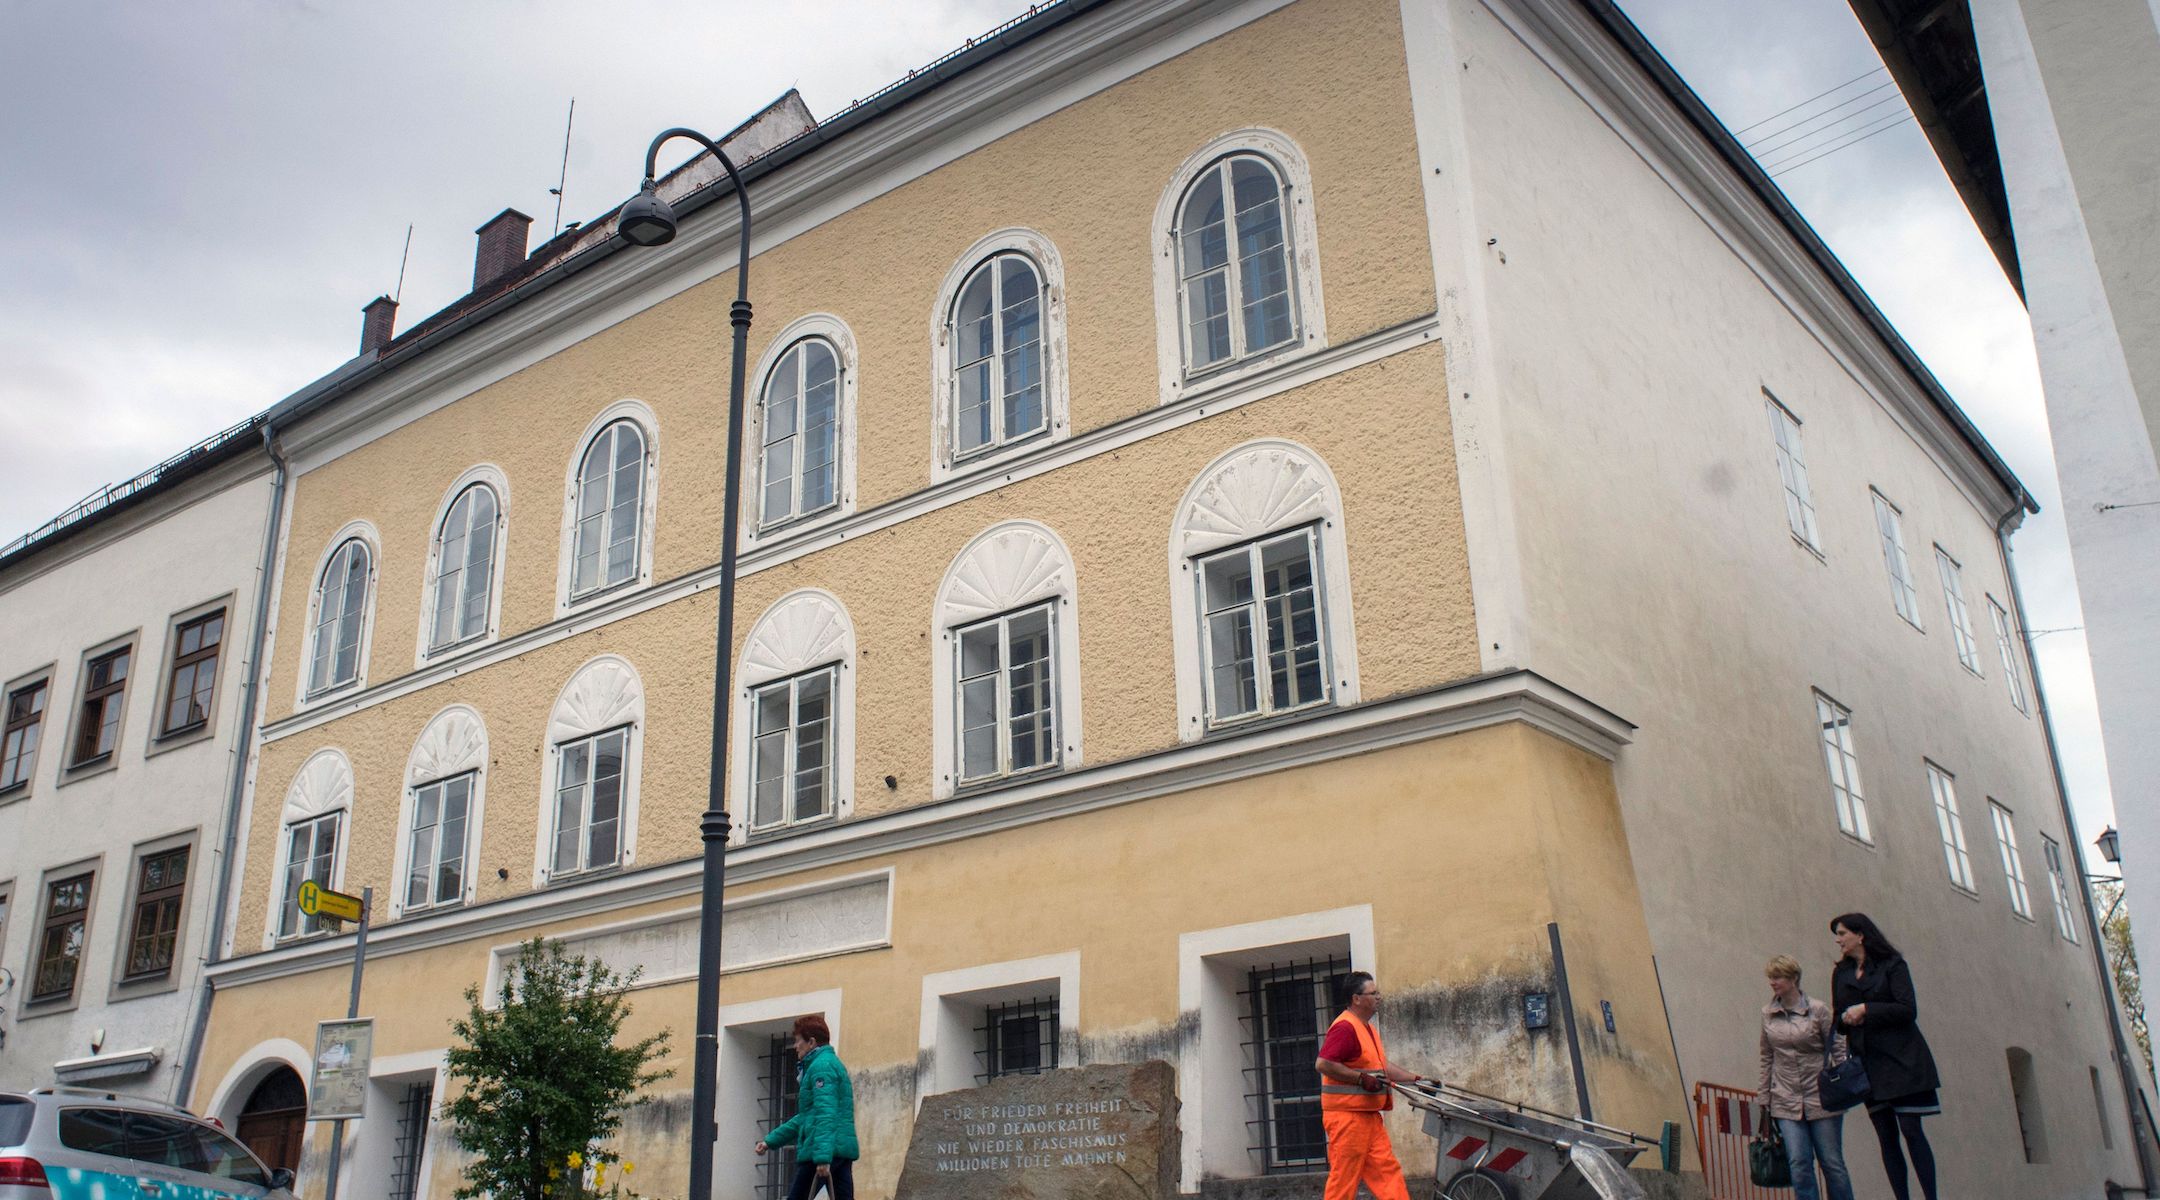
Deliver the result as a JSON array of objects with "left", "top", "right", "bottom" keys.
[{"left": 728, "top": 587, "right": 855, "bottom": 842}]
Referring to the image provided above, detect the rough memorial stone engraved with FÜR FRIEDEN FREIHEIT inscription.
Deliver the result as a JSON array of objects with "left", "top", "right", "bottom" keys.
[{"left": 899, "top": 1062, "right": 1177, "bottom": 1200}]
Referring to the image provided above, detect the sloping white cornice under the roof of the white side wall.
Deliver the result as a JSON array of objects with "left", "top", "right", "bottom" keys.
[{"left": 1482, "top": 0, "right": 2011, "bottom": 520}]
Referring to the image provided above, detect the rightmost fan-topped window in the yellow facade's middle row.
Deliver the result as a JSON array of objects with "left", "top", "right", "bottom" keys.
[{"left": 1171, "top": 440, "right": 1359, "bottom": 740}]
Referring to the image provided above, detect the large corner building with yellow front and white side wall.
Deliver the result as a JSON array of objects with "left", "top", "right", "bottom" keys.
[{"left": 177, "top": 0, "right": 2134, "bottom": 1200}]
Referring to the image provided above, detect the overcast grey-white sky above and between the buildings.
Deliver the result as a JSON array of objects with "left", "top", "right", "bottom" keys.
[{"left": 0, "top": 0, "right": 2112, "bottom": 840}]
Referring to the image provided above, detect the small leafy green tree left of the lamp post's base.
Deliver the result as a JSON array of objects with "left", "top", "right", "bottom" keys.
[{"left": 443, "top": 937, "right": 674, "bottom": 1200}]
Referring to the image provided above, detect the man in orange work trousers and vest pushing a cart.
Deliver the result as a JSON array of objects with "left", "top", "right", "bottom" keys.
[{"left": 1313, "top": 971, "right": 1423, "bottom": 1200}]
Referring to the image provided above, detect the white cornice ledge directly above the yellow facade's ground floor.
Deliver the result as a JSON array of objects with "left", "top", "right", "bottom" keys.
[{"left": 205, "top": 671, "right": 1635, "bottom": 986}]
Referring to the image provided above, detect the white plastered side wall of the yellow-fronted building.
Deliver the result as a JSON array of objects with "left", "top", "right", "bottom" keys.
[{"left": 1404, "top": 0, "right": 2134, "bottom": 1194}]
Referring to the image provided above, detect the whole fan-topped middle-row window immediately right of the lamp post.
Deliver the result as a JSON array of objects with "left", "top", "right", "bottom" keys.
[{"left": 734, "top": 589, "right": 855, "bottom": 833}]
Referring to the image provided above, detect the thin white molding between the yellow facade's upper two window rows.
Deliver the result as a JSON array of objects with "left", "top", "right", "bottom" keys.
[{"left": 261, "top": 315, "right": 1441, "bottom": 745}]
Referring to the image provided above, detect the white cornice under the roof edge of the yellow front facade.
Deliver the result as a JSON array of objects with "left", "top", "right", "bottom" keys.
[{"left": 279, "top": 0, "right": 1290, "bottom": 475}]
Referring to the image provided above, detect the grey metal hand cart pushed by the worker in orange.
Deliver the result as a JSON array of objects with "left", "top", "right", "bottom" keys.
[{"left": 1393, "top": 1079, "right": 1657, "bottom": 1200}]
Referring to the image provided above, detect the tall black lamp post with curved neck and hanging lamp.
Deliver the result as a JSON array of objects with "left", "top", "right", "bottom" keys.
[{"left": 616, "top": 127, "right": 750, "bottom": 1200}]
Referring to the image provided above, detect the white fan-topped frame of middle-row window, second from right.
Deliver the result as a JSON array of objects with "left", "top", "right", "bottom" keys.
[{"left": 931, "top": 520, "right": 1082, "bottom": 799}]
